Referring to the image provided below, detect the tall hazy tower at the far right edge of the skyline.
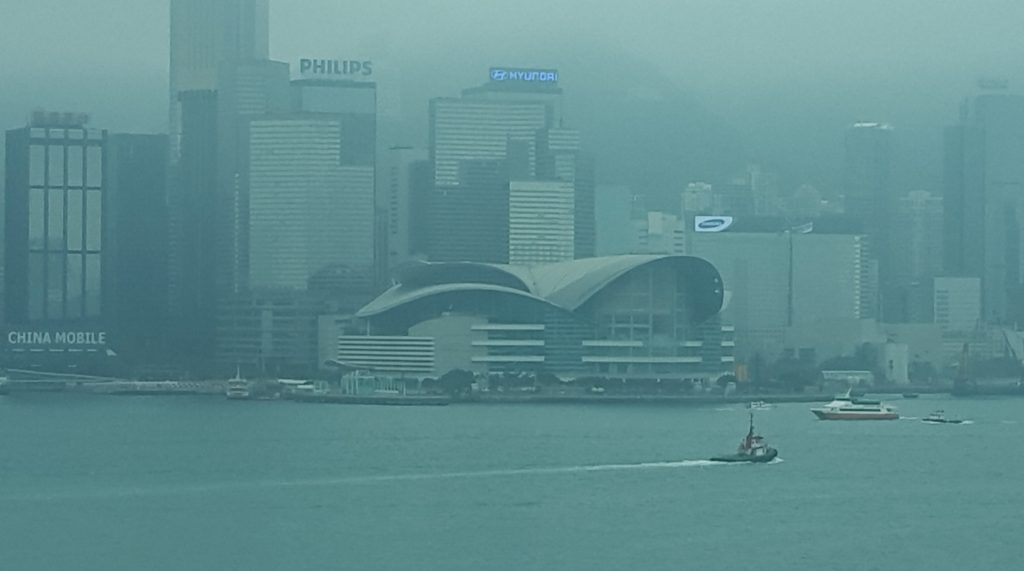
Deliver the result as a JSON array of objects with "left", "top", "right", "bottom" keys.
[{"left": 943, "top": 87, "right": 1024, "bottom": 323}]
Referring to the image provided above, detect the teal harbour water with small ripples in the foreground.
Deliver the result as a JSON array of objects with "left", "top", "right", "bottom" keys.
[{"left": 0, "top": 395, "right": 1024, "bottom": 571}]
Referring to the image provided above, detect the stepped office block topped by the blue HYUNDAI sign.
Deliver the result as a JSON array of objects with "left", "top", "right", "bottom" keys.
[{"left": 422, "top": 69, "right": 596, "bottom": 264}]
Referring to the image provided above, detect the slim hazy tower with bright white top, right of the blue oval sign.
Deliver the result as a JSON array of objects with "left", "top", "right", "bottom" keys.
[{"left": 844, "top": 123, "right": 895, "bottom": 313}]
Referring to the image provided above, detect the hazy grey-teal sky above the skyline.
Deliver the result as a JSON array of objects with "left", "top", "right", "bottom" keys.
[{"left": 0, "top": 0, "right": 1024, "bottom": 196}]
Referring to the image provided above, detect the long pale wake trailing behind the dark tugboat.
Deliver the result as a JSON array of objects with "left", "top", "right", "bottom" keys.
[{"left": 0, "top": 458, "right": 761, "bottom": 503}]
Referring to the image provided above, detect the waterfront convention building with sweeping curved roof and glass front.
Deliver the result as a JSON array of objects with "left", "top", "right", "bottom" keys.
[{"left": 337, "top": 256, "right": 732, "bottom": 378}]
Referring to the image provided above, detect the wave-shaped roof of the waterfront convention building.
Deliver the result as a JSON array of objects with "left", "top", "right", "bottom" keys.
[{"left": 357, "top": 255, "right": 723, "bottom": 317}]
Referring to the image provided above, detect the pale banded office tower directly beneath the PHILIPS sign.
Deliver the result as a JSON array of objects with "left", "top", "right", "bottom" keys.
[{"left": 217, "top": 79, "right": 377, "bottom": 370}]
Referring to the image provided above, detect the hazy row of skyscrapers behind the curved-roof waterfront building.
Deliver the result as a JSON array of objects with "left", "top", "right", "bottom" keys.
[{"left": 3, "top": 0, "right": 1024, "bottom": 375}]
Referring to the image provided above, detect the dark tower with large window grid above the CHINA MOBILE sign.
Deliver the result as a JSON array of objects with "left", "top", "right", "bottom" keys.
[{"left": 4, "top": 113, "right": 108, "bottom": 327}]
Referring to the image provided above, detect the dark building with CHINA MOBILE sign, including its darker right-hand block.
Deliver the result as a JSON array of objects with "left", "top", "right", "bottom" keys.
[{"left": 3, "top": 112, "right": 167, "bottom": 371}]
